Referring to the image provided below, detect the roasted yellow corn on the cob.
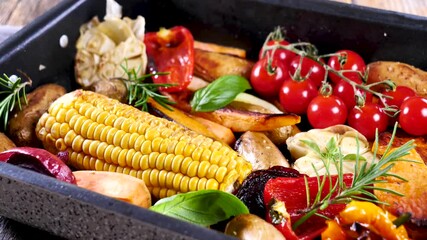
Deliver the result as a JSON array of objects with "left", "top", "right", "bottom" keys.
[{"left": 36, "top": 90, "right": 251, "bottom": 198}]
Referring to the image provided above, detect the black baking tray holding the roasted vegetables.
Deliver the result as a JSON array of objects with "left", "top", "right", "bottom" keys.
[{"left": 0, "top": 0, "right": 427, "bottom": 239}]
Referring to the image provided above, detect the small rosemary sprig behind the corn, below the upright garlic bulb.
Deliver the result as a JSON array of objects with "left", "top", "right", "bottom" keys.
[{"left": 117, "top": 61, "right": 174, "bottom": 111}]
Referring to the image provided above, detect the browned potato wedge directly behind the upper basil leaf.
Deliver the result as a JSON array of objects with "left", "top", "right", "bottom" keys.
[{"left": 194, "top": 49, "right": 254, "bottom": 82}]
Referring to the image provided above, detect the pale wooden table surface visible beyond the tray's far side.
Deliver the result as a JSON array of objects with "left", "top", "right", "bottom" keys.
[{"left": 0, "top": 0, "right": 427, "bottom": 26}]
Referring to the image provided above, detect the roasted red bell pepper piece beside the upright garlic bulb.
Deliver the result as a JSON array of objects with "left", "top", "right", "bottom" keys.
[{"left": 144, "top": 26, "right": 194, "bottom": 92}]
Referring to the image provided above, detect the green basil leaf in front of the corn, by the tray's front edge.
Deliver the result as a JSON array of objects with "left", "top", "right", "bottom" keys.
[{"left": 150, "top": 190, "right": 249, "bottom": 226}]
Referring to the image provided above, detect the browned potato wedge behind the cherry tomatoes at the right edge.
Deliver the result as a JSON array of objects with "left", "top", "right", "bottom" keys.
[{"left": 367, "top": 61, "right": 427, "bottom": 97}]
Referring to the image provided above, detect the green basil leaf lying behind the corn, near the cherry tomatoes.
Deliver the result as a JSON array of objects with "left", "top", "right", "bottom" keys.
[{"left": 190, "top": 75, "right": 251, "bottom": 112}]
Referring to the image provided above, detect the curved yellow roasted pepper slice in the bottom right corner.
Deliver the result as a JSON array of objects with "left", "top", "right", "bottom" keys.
[{"left": 322, "top": 201, "right": 409, "bottom": 240}]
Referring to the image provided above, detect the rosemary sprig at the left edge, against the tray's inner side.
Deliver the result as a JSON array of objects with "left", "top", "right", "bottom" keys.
[{"left": 0, "top": 74, "right": 31, "bottom": 130}]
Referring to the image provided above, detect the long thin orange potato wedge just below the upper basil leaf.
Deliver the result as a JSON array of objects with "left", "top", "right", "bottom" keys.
[{"left": 195, "top": 107, "right": 301, "bottom": 132}]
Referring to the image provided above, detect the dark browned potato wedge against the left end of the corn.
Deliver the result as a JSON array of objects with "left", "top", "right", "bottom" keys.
[{"left": 8, "top": 84, "right": 66, "bottom": 147}]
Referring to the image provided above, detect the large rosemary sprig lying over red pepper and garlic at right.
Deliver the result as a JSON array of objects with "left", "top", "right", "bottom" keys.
[{"left": 292, "top": 125, "right": 415, "bottom": 229}]
